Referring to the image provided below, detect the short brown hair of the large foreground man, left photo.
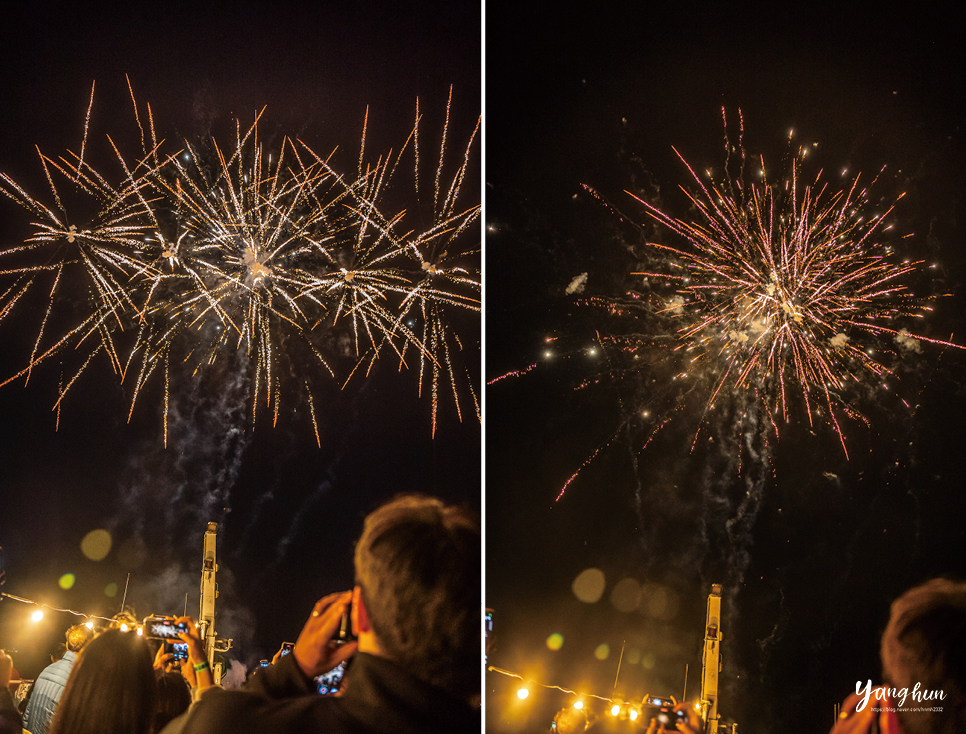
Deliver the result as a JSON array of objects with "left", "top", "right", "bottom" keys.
[{"left": 355, "top": 495, "right": 482, "bottom": 699}]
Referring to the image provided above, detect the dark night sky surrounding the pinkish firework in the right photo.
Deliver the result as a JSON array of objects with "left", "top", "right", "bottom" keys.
[{"left": 486, "top": 2, "right": 966, "bottom": 733}]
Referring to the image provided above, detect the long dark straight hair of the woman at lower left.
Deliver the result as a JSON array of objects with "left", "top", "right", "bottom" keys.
[{"left": 49, "top": 629, "right": 157, "bottom": 734}]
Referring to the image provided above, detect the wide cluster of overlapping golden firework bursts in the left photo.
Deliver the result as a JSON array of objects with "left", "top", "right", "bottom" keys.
[{"left": 0, "top": 83, "right": 480, "bottom": 443}]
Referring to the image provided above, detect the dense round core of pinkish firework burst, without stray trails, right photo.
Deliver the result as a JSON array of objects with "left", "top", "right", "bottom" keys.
[{"left": 590, "top": 108, "right": 961, "bottom": 466}]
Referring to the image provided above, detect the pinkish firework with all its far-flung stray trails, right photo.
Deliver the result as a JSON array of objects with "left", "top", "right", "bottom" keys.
[{"left": 520, "top": 110, "right": 963, "bottom": 500}]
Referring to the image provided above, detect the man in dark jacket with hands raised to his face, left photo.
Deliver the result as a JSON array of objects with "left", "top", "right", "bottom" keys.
[{"left": 163, "top": 496, "right": 482, "bottom": 734}]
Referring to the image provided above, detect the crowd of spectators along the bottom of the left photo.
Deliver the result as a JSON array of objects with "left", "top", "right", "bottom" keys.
[{"left": 0, "top": 495, "right": 482, "bottom": 734}]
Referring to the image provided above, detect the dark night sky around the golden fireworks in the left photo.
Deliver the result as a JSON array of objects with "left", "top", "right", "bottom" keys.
[{"left": 0, "top": 2, "right": 481, "bottom": 675}]
